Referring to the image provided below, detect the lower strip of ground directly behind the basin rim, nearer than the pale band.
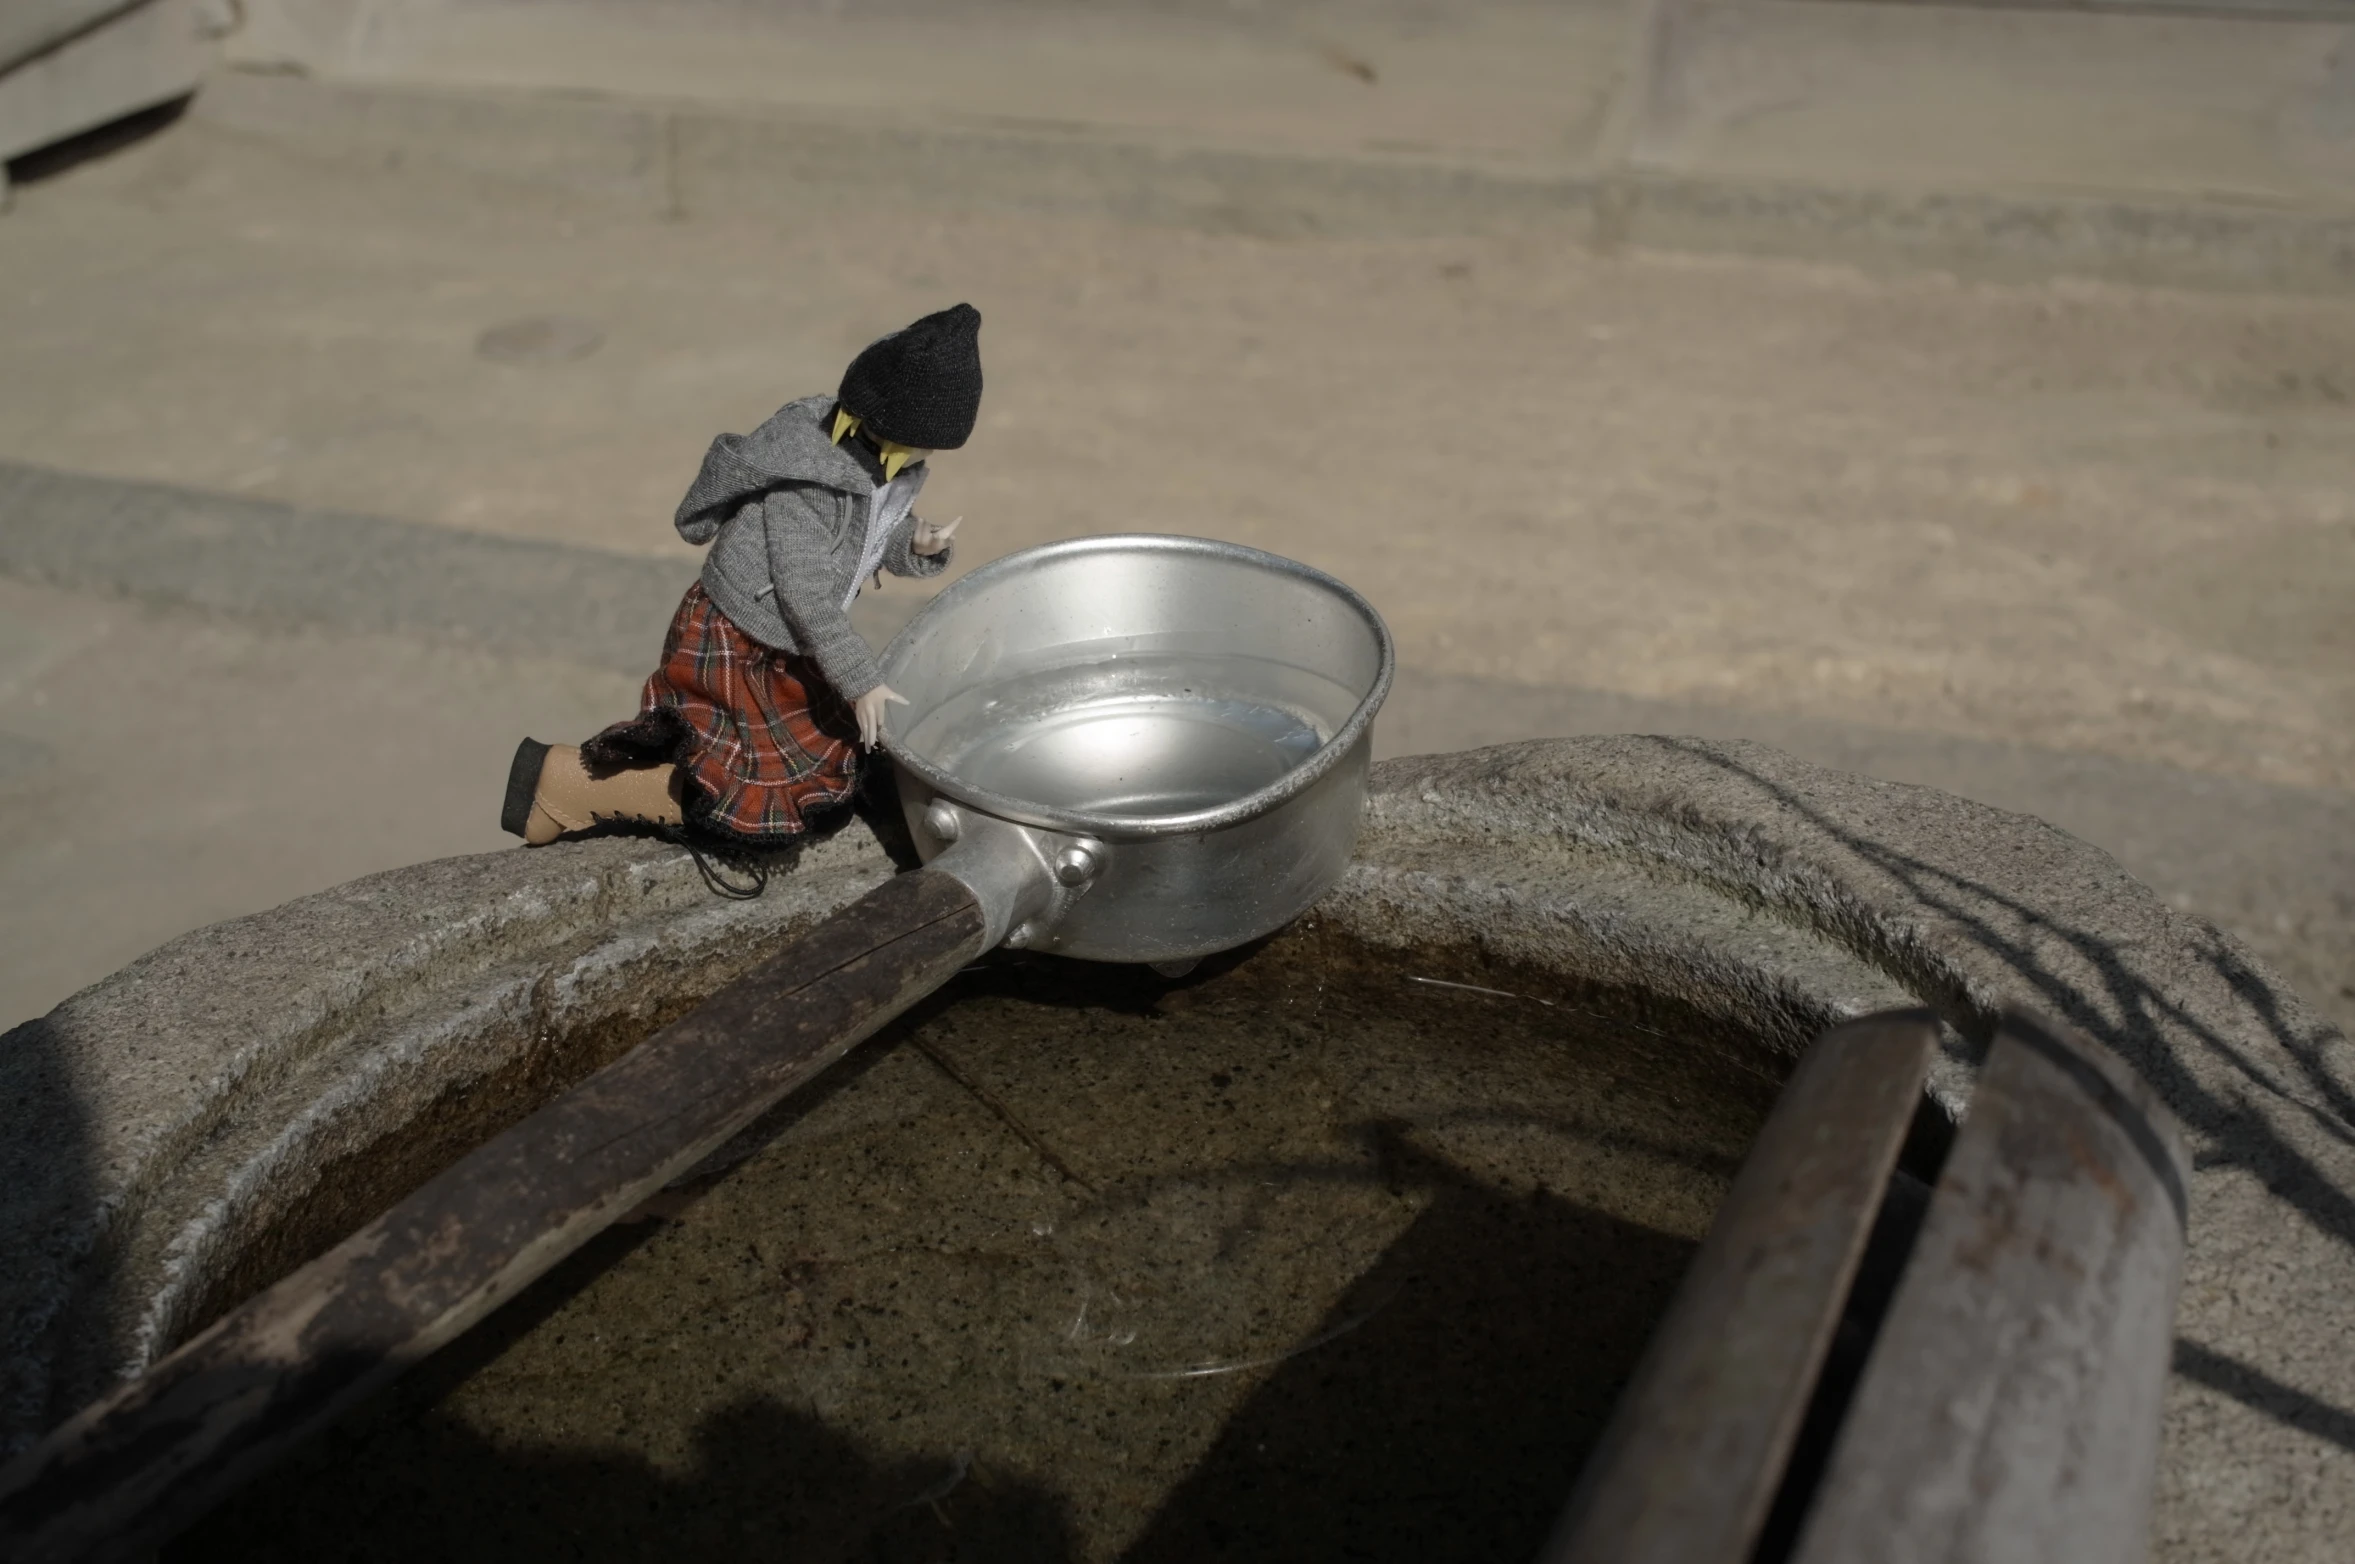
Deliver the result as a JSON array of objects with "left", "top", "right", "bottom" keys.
[{"left": 0, "top": 464, "right": 2355, "bottom": 1050}]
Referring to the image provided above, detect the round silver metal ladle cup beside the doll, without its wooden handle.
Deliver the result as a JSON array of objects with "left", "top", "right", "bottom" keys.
[{"left": 883, "top": 535, "right": 1392, "bottom": 963}]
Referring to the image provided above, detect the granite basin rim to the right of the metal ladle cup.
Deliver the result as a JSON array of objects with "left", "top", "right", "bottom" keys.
[{"left": 1356, "top": 737, "right": 2355, "bottom": 1562}]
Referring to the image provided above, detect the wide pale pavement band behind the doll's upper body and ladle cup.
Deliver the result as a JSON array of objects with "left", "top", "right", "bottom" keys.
[{"left": 0, "top": 122, "right": 2355, "bottom": 789}]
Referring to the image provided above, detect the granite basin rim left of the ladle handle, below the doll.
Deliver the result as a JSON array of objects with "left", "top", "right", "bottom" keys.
[{"left": 0, "top": 829, "right": 893, "bottom": 1449}]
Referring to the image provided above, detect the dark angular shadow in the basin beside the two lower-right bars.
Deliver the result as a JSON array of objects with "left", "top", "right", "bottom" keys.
[{"left": 1123, "top": 1126, "right": 1693, "bottom": 1564}]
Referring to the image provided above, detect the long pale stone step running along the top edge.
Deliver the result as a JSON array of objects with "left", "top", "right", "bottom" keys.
[{"left": 166, "top": 0, "right": 2355, "bottom": 290}]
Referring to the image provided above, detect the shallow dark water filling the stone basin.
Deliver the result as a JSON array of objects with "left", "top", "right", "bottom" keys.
[{"left": 167, "top": 926, "right": 1773, "bottom": 1564}]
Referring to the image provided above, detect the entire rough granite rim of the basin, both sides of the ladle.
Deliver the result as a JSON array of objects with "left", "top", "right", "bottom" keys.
[{"left": 0, "top": 737, "right": 2355, "bottom": 1562}]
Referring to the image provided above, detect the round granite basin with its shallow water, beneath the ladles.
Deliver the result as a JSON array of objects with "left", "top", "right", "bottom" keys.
[{"left": 0, "top": 740, "right": 2355, "bottom": 1559}]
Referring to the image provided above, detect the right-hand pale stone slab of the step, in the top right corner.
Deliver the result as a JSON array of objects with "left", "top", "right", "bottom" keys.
[{"left": 1630, "top": 0, "right": 2355, "bottom": 212}]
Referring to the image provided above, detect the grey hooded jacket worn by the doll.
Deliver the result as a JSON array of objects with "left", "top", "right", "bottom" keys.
[{"left": 678, "top": 396, "right": 949, "bottom": 700}]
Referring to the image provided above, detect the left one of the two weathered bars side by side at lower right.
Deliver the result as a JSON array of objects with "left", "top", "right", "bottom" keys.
[{"left": 1540, "top": 1010, "right": 1938, "bottom": 1564}]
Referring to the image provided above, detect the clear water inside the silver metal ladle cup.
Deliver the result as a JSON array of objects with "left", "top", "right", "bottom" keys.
[{"left": 904, "top": 652, "right": 1356, "bottom": 815}]
